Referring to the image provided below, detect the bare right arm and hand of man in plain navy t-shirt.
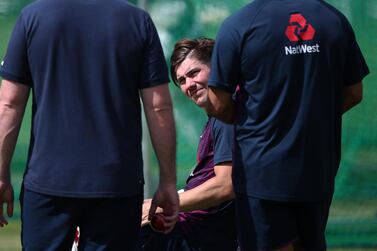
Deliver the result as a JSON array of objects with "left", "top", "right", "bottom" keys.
[{"left": 141, "top": 84, "right": 179, "bottom": 231}]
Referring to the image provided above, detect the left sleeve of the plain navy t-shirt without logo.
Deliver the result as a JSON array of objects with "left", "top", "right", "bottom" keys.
[{"left": 0, "top": 15, "right": 32, "bottom": 86}]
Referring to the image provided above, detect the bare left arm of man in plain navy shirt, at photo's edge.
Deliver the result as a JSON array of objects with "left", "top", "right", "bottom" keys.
[{"left": 0, "top": 80, "right": 29, "bottom": 227}]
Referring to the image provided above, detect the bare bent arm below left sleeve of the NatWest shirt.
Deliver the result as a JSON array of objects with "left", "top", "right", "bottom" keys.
[{"left": 205, "top": 87, "right": 235, "bottom": 124}]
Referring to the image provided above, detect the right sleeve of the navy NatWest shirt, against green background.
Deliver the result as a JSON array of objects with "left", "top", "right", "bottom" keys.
[{"left": 344, "top": 21, "right": 369, "bottom": 86}]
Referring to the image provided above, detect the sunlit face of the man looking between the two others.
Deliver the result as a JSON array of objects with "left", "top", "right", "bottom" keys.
[{"left": 176, "top": 58, "right": 210, "bottom": 107}]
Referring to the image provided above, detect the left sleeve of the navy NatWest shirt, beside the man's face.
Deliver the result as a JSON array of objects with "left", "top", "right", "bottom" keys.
[{"left": 208, "top": 18, "right": 241, "bottom": 93}]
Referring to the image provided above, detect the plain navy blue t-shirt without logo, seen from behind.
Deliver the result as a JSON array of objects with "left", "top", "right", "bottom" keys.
[{"left": 0, "top": 0, "right": 169, "bottom": 197}]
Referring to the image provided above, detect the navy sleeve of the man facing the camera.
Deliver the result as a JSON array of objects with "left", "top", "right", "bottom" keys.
[{"left": 212, "top": 119, "right": 234, "bottom": 165}]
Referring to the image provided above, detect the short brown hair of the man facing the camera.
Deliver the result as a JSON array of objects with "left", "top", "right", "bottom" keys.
[{"left": 170, "top": 37, "right": 215, "bottom": 86}]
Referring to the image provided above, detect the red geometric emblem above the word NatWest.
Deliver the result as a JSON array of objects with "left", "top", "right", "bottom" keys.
[{"left": 285, "top": 13, "right": 315, "bottom": 42}]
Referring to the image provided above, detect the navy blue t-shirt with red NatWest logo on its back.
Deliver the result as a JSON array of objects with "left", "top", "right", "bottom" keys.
[{"left": 209, "top": 0, "right": 369, "bottom": 201}]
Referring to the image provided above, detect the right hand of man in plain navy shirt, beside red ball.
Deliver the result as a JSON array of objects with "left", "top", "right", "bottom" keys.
[{"left": 148, "top": 185, "right": 179, "bottom": 234}]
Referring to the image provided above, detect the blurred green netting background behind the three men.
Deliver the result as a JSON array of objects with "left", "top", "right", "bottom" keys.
[{"left": 0, "top": 0, "right": 377, "bottom": 251}]
